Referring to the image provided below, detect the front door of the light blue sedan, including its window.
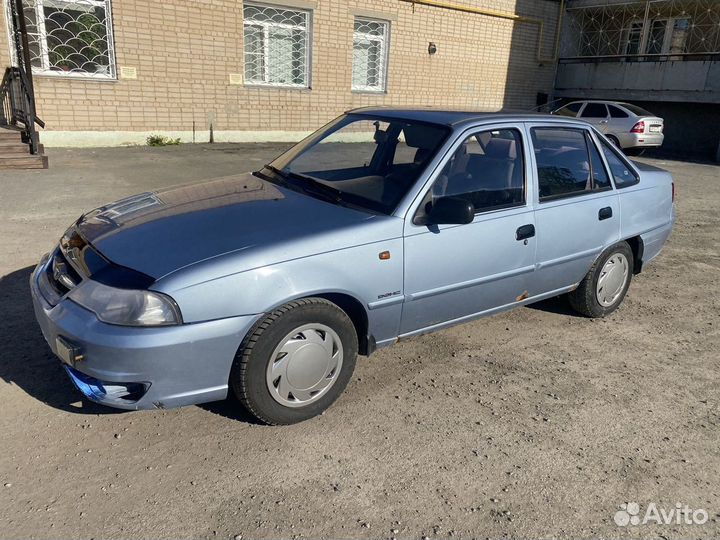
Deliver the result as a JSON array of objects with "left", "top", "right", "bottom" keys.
[{"left": 400, "top": 125, "right": 535, "bottom": 335}]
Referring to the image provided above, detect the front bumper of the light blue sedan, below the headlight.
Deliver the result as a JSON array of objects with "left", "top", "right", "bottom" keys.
[{"left": 30, "top": 262, "right": 259, "bottom": 409}]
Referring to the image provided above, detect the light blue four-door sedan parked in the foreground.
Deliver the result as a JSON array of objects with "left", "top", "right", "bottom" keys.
[{"left": 31, "top": 108, "right": 674, "bottom": 424}]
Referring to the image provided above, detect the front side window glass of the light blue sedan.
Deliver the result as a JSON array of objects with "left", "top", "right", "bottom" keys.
[{"left": 425, "top": 129, "right": 525, "bottom": 212}]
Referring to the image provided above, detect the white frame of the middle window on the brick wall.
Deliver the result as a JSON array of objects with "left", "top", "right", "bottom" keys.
[{"left": 243, "top": 2, "right": 313, "bottom": 89}]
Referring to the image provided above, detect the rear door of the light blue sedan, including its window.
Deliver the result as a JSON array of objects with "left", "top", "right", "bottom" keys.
[{"left": 528, "top": 123, "right": 620, "bottom": 296}]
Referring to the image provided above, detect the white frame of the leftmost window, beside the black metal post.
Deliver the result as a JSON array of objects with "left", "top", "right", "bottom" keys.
[{"left": 5, "top": 0, "right": 117, "bottom": 80}]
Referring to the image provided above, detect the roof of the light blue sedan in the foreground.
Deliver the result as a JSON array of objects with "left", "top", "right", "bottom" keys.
[{"left": 347, "top": 107, "right": 587, "bottom": 127}]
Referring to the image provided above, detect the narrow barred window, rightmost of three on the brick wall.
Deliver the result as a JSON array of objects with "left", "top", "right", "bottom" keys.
[{"left": 352, "top": 17, "right": 390, "bottom": 92}]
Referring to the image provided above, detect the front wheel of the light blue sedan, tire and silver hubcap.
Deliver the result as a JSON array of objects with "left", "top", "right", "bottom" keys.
[{"left": 229, "top": 298, "right": 358, "bottom": 425}]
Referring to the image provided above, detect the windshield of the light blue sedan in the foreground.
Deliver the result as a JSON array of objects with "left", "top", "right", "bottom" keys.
[{"left": 266, "top": 114, "right": 450, "bottom": 214}]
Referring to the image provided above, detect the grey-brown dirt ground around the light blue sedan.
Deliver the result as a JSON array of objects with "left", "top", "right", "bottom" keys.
[{"left": 0, "top": 145, "right": 720, "bottom": 539}]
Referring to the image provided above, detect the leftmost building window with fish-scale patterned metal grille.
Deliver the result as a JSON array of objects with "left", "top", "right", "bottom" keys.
[{"left": 8, "top": 0, "right": 115, "bottom": 79}]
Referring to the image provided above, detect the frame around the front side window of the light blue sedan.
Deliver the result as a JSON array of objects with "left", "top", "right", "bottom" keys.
[{"left": 406, "top": 122, "right": 530, "bottom": 227}]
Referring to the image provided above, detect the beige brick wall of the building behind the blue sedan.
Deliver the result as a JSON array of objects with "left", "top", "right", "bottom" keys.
[{"left": 0, "top": 0, "right": 559, "bottom": 143}]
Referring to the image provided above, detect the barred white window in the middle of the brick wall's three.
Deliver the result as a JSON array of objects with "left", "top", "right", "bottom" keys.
[{"left": 243, "top": 3, "right": 310, "bottom": 88}]
